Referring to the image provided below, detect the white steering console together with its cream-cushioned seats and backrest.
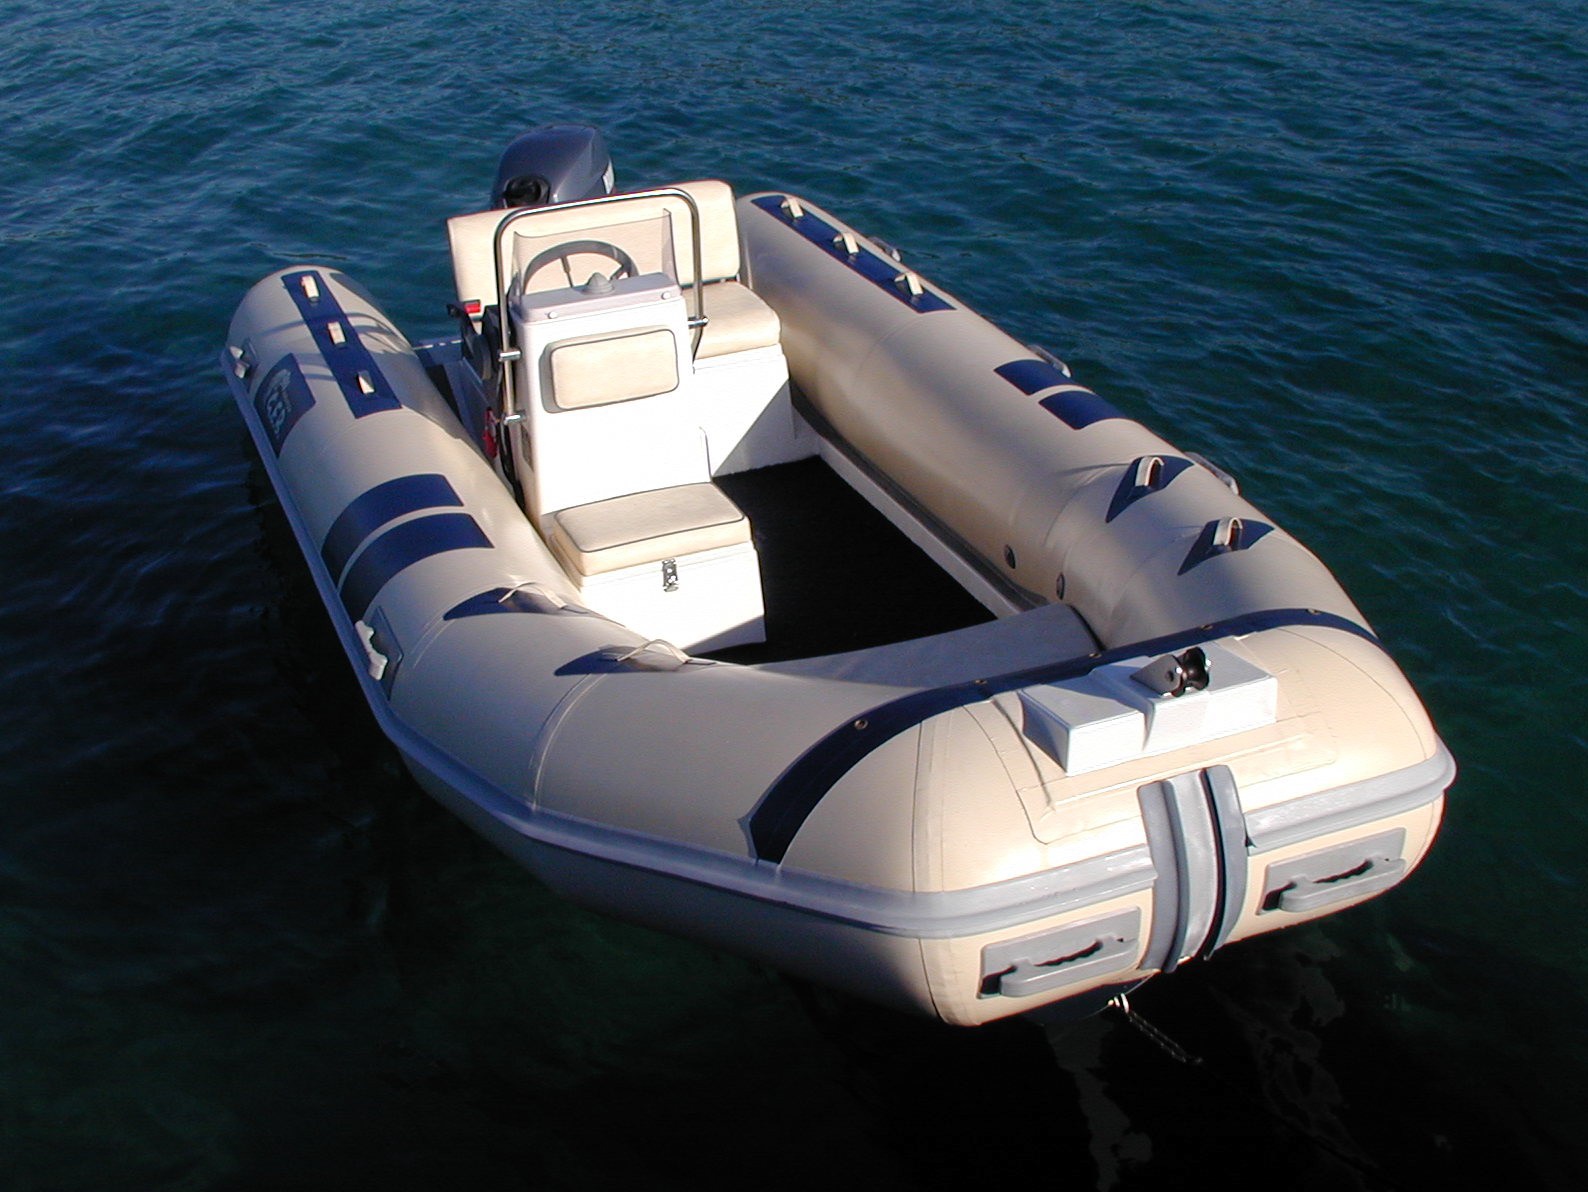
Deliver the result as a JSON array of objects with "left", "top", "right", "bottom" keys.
[{"left": 448, "top": 181, "right": 815, "bottom": 651}]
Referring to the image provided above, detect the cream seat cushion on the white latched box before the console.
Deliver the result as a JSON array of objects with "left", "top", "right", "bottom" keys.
[{"left": 546, "top": 483, "right": 750, "bottom": 575}]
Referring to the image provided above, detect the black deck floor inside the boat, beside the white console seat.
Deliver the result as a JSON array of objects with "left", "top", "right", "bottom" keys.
[{"left": 708, "top": 459, "right": 993, "bottom": 663}]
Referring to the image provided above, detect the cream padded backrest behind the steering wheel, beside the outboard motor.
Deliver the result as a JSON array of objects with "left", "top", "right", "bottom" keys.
[{"left": 446, "top": 179, "right": 740, "bottom": 314}]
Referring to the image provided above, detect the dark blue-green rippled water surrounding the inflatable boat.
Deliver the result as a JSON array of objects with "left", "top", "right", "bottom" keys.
[{"left": 0, "top": 0, "right": 1588, "bottom": 1190}]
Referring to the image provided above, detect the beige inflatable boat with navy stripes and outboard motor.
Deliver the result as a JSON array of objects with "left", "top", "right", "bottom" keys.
[{"left": 222, "top": 125, "right": 1455, "bottom": 1024}]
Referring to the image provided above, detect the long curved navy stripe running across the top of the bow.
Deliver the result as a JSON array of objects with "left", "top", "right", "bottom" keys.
[{"left": 750, "top": 608, "right": 1378, "bottom": 862}]
